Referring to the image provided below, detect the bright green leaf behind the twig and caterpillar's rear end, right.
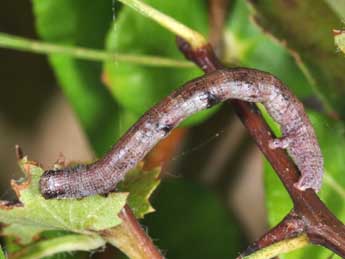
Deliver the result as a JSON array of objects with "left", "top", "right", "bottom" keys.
[{"left": 265, "top": 112, "right": 345, "bottom": 259}]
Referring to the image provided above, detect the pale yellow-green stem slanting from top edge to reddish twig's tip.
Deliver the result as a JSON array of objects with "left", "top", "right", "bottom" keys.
[{"left": 119, "top": 0, "right": 207, "bottom": 49}]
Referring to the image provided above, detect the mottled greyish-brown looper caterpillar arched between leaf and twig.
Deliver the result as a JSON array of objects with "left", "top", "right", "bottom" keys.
[{"left": 40, "top": 68, "right": 323, "bottom": 199}]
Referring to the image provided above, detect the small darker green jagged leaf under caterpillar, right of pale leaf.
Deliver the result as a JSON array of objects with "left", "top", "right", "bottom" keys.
[{"left": 118, "top": 165, "right": 161, "bottom": 218}]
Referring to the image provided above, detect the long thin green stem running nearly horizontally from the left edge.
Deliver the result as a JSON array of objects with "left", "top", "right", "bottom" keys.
[{"left": 0, "top": 32, "right": 193, "bottom": 68}]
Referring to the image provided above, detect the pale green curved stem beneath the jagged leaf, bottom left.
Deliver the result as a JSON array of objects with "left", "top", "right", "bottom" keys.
[{"left": 9, "top": 235, "right": 105, "bottom": 259}]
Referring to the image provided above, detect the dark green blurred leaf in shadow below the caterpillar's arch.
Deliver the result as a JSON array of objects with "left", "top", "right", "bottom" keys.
[{"left": 143, "top": 179, "right": 246, "bottom": 259}]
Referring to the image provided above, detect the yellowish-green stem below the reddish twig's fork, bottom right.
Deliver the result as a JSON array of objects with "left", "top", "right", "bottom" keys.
[{"left": 239, "top": 234, "right": 310, "bottom": 259}]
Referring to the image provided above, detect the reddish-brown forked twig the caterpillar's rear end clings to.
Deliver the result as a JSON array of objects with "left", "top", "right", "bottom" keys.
[{"left": 177, "top": 38, "right": 345, "bottom": 258}]
